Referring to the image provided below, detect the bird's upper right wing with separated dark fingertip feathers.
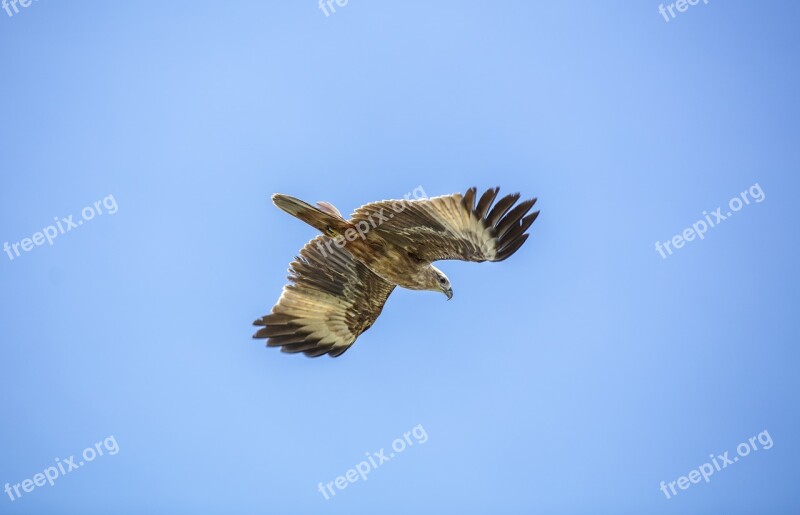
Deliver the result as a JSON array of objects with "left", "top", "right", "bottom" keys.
[{"left": 350, "top": 188, "right": 539, "bottom": 262}]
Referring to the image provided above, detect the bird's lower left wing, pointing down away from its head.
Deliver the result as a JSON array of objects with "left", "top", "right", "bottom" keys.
[{"left": 253, "top": 236, "right": 395, "bottom": 357}]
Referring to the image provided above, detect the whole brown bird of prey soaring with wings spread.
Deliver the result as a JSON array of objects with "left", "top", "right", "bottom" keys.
[{"left": 253, "top": 187, "right": 539, "bottom": 357}]
